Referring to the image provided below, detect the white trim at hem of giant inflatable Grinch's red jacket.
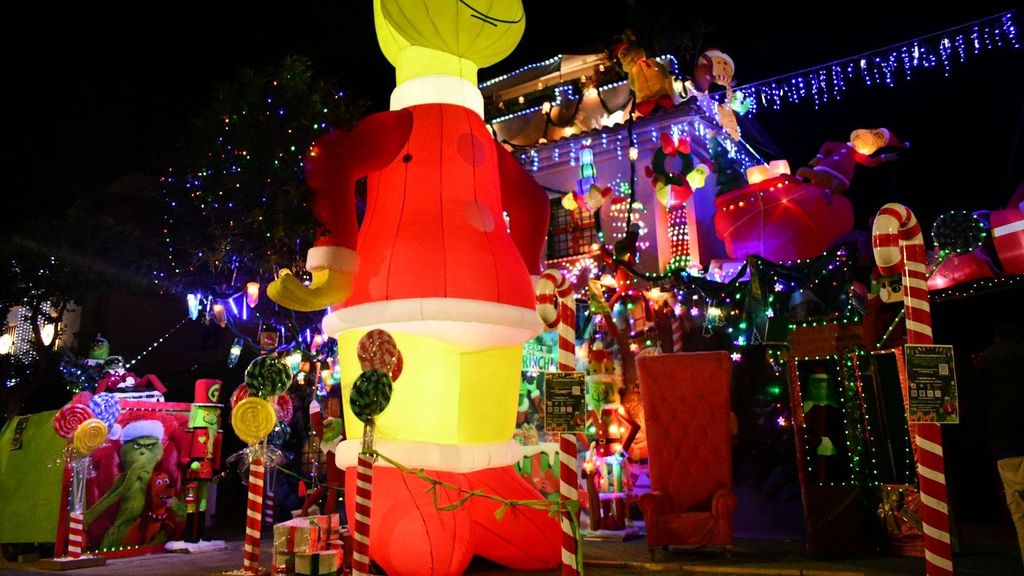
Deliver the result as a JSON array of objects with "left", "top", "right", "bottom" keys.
[{"left": 324, "top": 298, "right": 544, "bottom": 352}]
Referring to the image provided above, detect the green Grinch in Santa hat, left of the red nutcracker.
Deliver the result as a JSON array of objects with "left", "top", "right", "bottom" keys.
[{"left": 85, "top": 420, "right": 164, "bottom": 548}]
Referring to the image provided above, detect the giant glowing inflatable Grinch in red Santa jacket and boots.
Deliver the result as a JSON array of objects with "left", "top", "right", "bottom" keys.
[{"left": 267, "top": 0, "right": 560, "bottom": 575}]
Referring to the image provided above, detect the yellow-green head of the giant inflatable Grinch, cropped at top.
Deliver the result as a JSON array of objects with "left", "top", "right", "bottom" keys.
[{"left": 374, "top": 0, "right": 526, "bottom": 68}]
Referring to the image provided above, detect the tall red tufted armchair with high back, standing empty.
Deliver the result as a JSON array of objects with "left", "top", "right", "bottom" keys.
[{"left": 637, "top": 352, "right": 736, "bottom": 558}]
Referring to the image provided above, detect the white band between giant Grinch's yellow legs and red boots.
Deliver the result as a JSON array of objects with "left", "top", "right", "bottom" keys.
[{"left": 335, "top": 439, "right": 522, "bottom": 472}]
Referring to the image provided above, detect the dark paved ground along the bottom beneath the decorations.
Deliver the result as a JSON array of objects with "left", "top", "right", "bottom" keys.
[{"left": 0, "top": 528, "right": 1024, "bottom": 576}]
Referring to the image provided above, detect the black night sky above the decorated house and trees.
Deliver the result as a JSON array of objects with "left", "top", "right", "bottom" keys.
[{"left": 9, "top": 0, "right": 1024, "bottom": 230}]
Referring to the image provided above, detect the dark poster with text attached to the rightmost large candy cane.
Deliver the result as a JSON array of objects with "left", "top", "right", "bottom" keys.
[{"left": 903, "top": 344, "right": 959, "bottom": 424}]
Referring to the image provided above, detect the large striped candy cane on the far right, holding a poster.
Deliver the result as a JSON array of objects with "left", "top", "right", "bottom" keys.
[{"left": 871, "top": 203, "right": 953, "bottom": 576}]
